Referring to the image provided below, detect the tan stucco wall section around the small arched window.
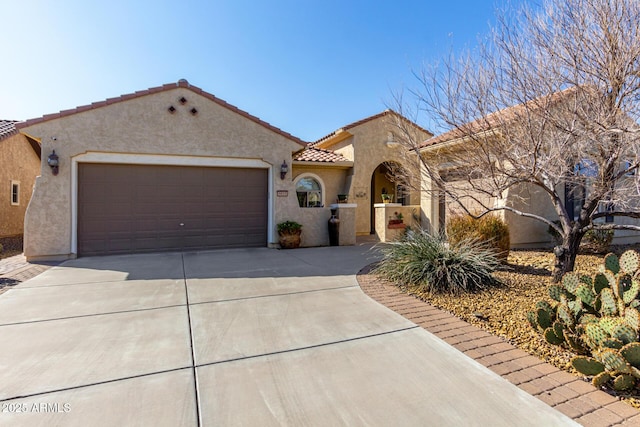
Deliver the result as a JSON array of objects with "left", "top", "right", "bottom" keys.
[{"left": 292, "top": 164, "right": 349, "bottom": 246}]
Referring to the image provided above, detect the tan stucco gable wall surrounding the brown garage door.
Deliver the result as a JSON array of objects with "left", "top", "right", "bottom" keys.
[{"left": 22, "top": 87, "right": 301, "bottom": 259}]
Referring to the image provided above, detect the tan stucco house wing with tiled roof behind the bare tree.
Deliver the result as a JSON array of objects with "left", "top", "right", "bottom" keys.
[{"left": 419, "top": 89, "right": 640, "bottom": 248}]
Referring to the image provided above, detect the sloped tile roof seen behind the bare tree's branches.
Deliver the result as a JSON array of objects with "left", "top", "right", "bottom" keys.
[{"left": 420, "top": 87, "right": 576, "bottom": 148}]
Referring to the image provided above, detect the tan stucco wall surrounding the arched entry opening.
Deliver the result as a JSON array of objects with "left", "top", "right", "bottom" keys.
[{"left": 329, "top": 116, "right": 428, "bottom": 235}]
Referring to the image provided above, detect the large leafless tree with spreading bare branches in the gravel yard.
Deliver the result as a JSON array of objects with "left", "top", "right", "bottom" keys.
[{"left": 394, "top": 0, "right": 640, "bottom": 279}]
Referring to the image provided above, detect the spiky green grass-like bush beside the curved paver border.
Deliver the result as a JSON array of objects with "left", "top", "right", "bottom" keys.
[{"left": 374, "top": 230, "right": 500, "bottom": 294}]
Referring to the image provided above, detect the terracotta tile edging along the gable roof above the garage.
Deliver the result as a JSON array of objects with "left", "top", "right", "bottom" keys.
[{"left": 16, "top": 79, "right": 307, "bottom": 146}]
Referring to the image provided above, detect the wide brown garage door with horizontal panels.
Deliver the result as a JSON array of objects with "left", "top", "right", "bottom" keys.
[{"left": 78, "top": 163, "right": 268, "bottom": 255}]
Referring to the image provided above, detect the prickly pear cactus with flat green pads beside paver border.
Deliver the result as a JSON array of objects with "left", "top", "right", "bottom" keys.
[{"left": 527, "top": 251, "right": 640, "bottom": 391}]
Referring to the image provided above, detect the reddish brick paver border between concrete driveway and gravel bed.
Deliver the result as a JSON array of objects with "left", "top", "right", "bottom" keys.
[{"left": 357, "top": 266, "right": 640, "bottom": 427}]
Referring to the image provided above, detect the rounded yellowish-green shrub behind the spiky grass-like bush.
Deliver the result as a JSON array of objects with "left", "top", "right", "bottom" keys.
[{"left": 447, "top": 215, "right": 511, "bottom": 262}]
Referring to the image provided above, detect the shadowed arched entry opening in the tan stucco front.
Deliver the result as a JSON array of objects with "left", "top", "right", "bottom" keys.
[{"left": 369, "top": 162, "right": 411, "bottom": 234}]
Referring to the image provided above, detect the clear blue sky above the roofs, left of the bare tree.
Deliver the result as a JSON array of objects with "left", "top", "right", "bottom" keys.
[{"left": 0, "top": 0, "right": 526, "bottom": 141}]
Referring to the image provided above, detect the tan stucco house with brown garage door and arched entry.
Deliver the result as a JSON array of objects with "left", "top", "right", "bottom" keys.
[{"left": 16, "top": 80, "right": 430, "bottom": 259}]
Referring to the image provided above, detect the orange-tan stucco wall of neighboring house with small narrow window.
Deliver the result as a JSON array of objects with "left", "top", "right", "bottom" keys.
[{"left": 0, "top": 134, "right": 40, "bottom": 237}]
